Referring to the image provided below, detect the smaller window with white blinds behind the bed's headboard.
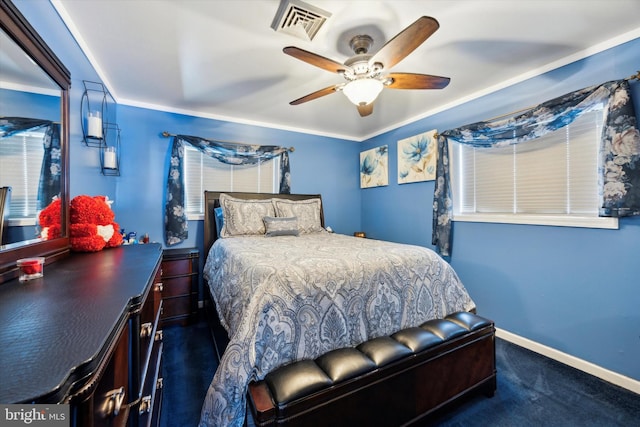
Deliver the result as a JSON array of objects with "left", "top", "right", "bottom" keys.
[{"left": 184, "top": 144, "right": 280, "bottom": 217}]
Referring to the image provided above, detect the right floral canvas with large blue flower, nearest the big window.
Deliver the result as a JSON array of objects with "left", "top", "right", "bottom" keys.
[{"left": 398, "top": 129, "right": 438, "bottom": 184}]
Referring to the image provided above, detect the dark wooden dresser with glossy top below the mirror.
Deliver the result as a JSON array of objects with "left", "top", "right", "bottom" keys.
[{"left": 0, "top": 244, "right": 163, "bottom": 427}]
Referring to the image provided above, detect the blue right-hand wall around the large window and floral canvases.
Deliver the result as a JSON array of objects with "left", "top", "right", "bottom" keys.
[{"left": 361, "top": 39, "right": 640, "bottom": 380}]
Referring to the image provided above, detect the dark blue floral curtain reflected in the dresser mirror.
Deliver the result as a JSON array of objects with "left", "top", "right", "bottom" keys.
[{"left": 0, "top": 117, "right": 62, "bottom": 210}]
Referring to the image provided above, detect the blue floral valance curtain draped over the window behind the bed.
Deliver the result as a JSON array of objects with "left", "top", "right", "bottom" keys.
[{"left": 164, "top": 135, "right": 291, "bottom": 246}]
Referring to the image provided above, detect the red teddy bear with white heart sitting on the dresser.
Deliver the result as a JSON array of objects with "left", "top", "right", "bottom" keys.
[{"left": 69, "top": 196, "right": 122, "bottom": 252}]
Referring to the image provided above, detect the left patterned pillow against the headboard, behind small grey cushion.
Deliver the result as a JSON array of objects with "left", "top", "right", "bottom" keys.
[{"left": 220, "top": 193, "right": 275, "bottom": 238}]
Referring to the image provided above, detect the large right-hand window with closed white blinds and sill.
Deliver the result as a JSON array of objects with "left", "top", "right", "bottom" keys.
[{"left": 450, "top": 108, "right": 617, "bottom": 228}]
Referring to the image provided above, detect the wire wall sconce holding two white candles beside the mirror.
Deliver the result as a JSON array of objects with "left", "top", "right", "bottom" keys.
[{"left": 80, "top": 80, "right": 120, "bottom": 176}]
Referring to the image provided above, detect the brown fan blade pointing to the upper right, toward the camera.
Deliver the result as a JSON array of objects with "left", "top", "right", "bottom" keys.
[{"left": 369, "top": 16, "right": 440, "bottom": 70}]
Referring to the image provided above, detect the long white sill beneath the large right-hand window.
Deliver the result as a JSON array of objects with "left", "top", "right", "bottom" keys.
[{"left": 453, "top": 214, "right": 618, "bottom": 230}]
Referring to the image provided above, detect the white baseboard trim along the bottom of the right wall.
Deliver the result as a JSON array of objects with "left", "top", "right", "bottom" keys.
[{"left": 496, "top": 328, "right": 640, "bottom": 394}]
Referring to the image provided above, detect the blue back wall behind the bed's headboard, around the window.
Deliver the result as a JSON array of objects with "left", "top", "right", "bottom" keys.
[{"left": 114, "top": 105, "right": 360, "bottom": 248}]
